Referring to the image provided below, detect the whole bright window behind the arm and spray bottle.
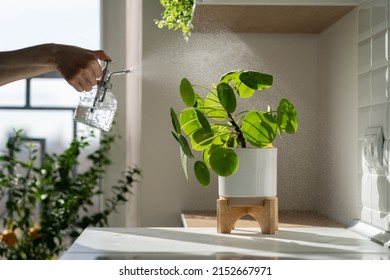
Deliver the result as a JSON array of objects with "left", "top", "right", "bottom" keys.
[{"left": 0, "top": 0, "right": 100, "bottom": 153}]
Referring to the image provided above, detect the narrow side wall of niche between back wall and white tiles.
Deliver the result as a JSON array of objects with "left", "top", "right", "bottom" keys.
[{"left": 316, "top": 9, "right": 358, "bottom": 224}]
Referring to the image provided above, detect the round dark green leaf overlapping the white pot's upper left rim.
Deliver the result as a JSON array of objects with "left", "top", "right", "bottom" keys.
[{"left": 210, "top": 148, "right": 239, "bottom": 176}]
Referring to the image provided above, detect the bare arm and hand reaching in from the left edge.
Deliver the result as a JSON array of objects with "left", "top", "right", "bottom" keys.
[{"left": 0, "top": 44, "right": 111, "bottom": 92}]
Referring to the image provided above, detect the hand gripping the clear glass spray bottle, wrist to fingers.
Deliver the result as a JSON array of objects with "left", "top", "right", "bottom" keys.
[{"left": 54, "top": 45, "right": 111, "bottom": 92}]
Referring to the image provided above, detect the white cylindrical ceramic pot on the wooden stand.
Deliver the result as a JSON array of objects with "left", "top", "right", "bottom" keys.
[{"left": 218, "top": 148, "right": 277, "bottom": 197}]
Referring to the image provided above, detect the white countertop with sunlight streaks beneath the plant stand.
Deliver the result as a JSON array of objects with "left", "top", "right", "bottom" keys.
[{"left": 61, "top": 227, "right": 390, "bottom": 260}]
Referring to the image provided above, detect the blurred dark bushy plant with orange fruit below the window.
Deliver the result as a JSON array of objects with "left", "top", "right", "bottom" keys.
[{"left": 0, "top": 130, "right": 140, "bottom": 260}]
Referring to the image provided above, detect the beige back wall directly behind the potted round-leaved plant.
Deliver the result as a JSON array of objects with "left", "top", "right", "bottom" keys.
[{"left": 140, "top": 1, "right": 322, "bottom": 226}]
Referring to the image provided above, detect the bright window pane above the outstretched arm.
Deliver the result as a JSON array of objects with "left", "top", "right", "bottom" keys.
[{"left": 0, "top": 0, "right": 100, "bottom": 50}]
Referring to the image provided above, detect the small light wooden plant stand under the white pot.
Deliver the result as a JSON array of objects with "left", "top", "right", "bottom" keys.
[{"left": 217, "top": 197, "right": 279, "bottom": 234}]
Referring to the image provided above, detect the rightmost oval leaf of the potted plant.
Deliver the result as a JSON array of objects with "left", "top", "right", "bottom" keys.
[{"left": 277, "top": 98, "right": 298, "bottom": 134}]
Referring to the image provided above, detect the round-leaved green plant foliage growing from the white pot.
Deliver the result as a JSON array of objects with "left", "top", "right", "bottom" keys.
[{"left": 170, "top": 70, "right": 298, "bottom": 189}]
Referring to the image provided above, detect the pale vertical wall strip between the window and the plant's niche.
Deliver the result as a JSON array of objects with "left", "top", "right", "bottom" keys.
[{"left": 101, "top": 0, "right": 142, "bottom": 226}]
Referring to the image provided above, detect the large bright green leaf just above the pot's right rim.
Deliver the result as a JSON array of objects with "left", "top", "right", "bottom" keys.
[{"left": 241, "top": 111, "right": 278, "bottom": 148}]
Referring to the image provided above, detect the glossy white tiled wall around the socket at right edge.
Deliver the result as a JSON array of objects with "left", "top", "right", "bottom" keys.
[{"left": 358, "top": 0, "right": 390, "bottom": 230}]
